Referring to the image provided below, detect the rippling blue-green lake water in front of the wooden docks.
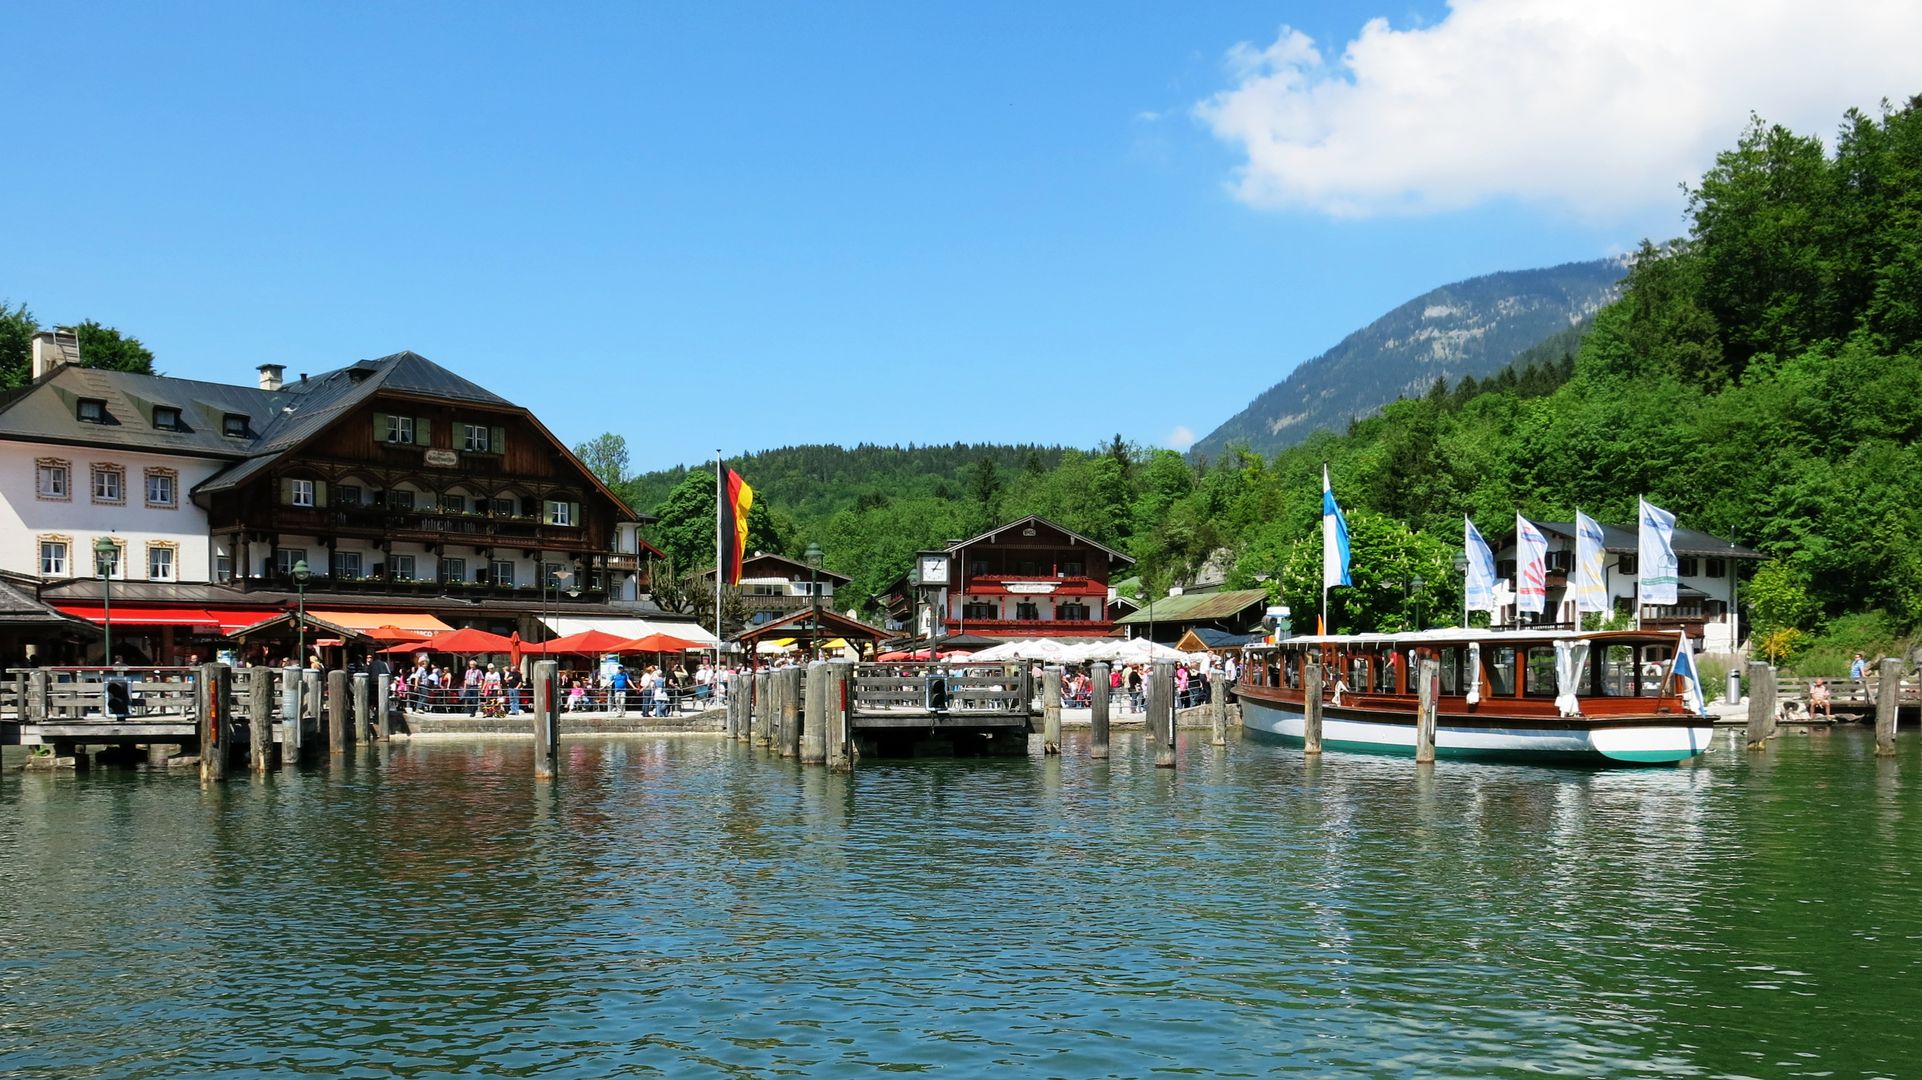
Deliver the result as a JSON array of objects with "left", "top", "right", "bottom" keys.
[{"left": 0, "top": 732, "right": 1922, "bottom": 1078}]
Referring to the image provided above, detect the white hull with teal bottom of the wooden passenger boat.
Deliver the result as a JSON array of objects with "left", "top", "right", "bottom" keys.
[{"left": 1242, "top": 694, "right": 1714, "bottom": 765}]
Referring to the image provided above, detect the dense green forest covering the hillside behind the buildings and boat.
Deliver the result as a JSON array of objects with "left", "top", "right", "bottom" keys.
[{"left": 638, "top": 100, "right": 1922, "bottom": 668}]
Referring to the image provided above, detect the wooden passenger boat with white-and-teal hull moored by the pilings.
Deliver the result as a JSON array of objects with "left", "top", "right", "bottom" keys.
[{"left": 1236, "top": 628, "right": 1714, "bottom": 765}]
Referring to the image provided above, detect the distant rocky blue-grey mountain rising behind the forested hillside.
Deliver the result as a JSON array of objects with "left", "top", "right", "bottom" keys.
[{"left": 1192, "top": 258, "right": 1628, "bottom": 457}]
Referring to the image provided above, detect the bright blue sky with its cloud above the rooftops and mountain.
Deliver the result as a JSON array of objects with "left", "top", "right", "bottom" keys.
[{"left": 0, "top": 0, "right": 1912, "bottom": 469}]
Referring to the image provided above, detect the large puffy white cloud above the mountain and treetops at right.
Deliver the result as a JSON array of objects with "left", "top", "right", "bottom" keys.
[{"left": 1194, "top": 0, "right": 1922, "bottom": 217}]
